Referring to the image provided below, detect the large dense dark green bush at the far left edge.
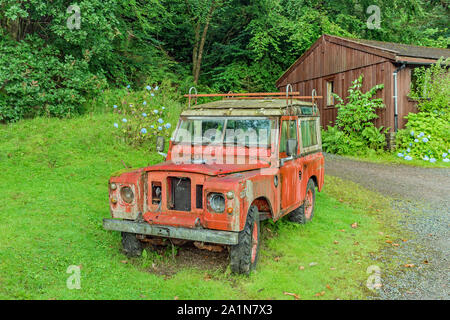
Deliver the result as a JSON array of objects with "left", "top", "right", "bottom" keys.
[{"left": 0, "top": 36, "right": 106, "bottom": 122}]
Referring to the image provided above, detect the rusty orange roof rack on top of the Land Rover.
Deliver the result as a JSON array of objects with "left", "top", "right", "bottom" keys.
[{"left": 184, "top": 83, "right": 323, "bottom": 109}]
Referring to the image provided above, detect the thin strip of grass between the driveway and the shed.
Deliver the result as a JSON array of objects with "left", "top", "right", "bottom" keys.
[{"left": 344, "top": 152, "right": 450, "bottom": 168}]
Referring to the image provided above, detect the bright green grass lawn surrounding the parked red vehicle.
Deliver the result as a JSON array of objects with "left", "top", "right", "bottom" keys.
[{"left": 0, "top": 114, "right": 389, "bottom": 299}]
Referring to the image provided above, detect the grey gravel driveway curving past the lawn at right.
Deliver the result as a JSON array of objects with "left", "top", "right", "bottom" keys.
[{"left": 325, "top": 154, "right": 450, "bottom": 300}]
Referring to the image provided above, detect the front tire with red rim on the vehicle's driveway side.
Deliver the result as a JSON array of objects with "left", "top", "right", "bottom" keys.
[{"left": 230, "top": 206, "right": 261, "bottom": 275}]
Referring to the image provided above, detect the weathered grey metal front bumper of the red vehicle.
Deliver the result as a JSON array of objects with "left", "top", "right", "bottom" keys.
[{"left": 103, "top": 219, "right": 239, "bottom": 245}]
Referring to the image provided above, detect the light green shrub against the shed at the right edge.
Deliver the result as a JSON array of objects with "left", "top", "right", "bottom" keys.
[{"left": 409, "top": 58, "right": 450, "bottom": 114}]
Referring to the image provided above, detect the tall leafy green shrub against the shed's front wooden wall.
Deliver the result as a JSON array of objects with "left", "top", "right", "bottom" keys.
[{"left": 322, "top": 75, "right": 387, "bottom": 154}]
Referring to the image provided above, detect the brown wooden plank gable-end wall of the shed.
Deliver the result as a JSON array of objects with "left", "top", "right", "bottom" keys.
[{"left": 278, "top": 40, "right": 395, "bottom": 130}]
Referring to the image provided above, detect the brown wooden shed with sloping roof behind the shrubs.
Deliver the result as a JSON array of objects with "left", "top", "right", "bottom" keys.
[{"left": 276, "top": 34, "right": 450, "bottom": 136}]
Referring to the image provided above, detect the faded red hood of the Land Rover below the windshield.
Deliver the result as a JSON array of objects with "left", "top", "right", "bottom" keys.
[{"left": 144, "top": 161, "right": 270, "bottom": 176}]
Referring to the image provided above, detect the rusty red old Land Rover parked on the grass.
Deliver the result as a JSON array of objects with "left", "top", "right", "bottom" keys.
[{"left": 103, "top": 91, "right": 324, "bottom": 274}]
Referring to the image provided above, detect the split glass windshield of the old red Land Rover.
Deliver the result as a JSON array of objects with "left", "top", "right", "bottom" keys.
[{"left": 174, "top": 117, "right": 275, "bottom": 147}]
